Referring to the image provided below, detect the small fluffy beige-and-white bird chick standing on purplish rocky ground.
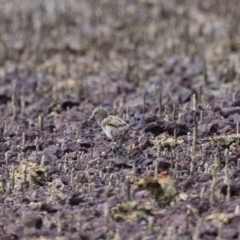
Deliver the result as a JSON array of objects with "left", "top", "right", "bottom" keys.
[{"left": 90, "top": 107, "right": 129, "bottom": 143}]
